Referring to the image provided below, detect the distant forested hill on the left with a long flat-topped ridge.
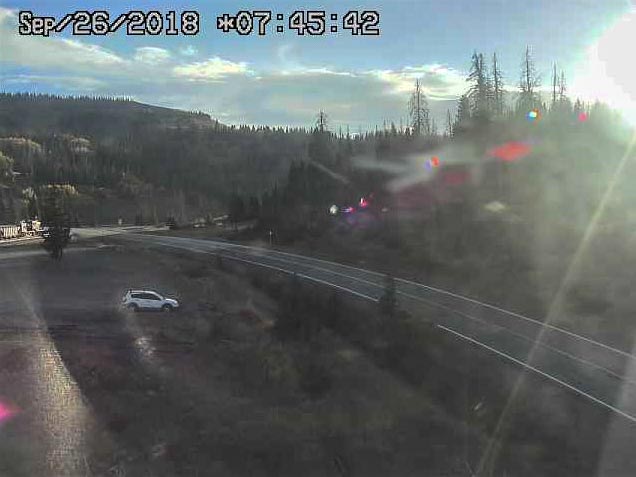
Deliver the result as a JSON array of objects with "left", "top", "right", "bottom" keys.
[{"left": 0, "top": 94, "right": 307, "bottom": 223}]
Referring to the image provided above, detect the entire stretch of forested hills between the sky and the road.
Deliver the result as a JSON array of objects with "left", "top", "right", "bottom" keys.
[{"left": 0, "top": 44, "right": 636, "bottom": 342}]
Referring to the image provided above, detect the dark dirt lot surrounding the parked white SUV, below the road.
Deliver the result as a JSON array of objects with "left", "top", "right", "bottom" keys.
[{"left": 0, "top": 245, "right": 466, "bottom": 476}]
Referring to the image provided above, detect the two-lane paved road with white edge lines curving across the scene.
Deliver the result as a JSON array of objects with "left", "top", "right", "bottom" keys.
[{"left": 80, "top": 229, "right": 636, "bottom": 425}]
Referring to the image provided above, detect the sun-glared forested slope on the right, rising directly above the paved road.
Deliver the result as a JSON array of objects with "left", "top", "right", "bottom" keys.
[{"left": 231, "top": 50, "right": 636, "bottom": 349}]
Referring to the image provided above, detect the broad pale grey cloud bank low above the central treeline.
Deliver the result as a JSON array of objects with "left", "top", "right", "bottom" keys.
[{"left": 148, "top": 69, "right": 455, "bottom": 130}]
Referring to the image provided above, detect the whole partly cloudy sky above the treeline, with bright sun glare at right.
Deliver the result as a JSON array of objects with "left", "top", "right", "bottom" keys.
[{"left": 0, "top": 0, "right": 636, "bottom": 132}]
